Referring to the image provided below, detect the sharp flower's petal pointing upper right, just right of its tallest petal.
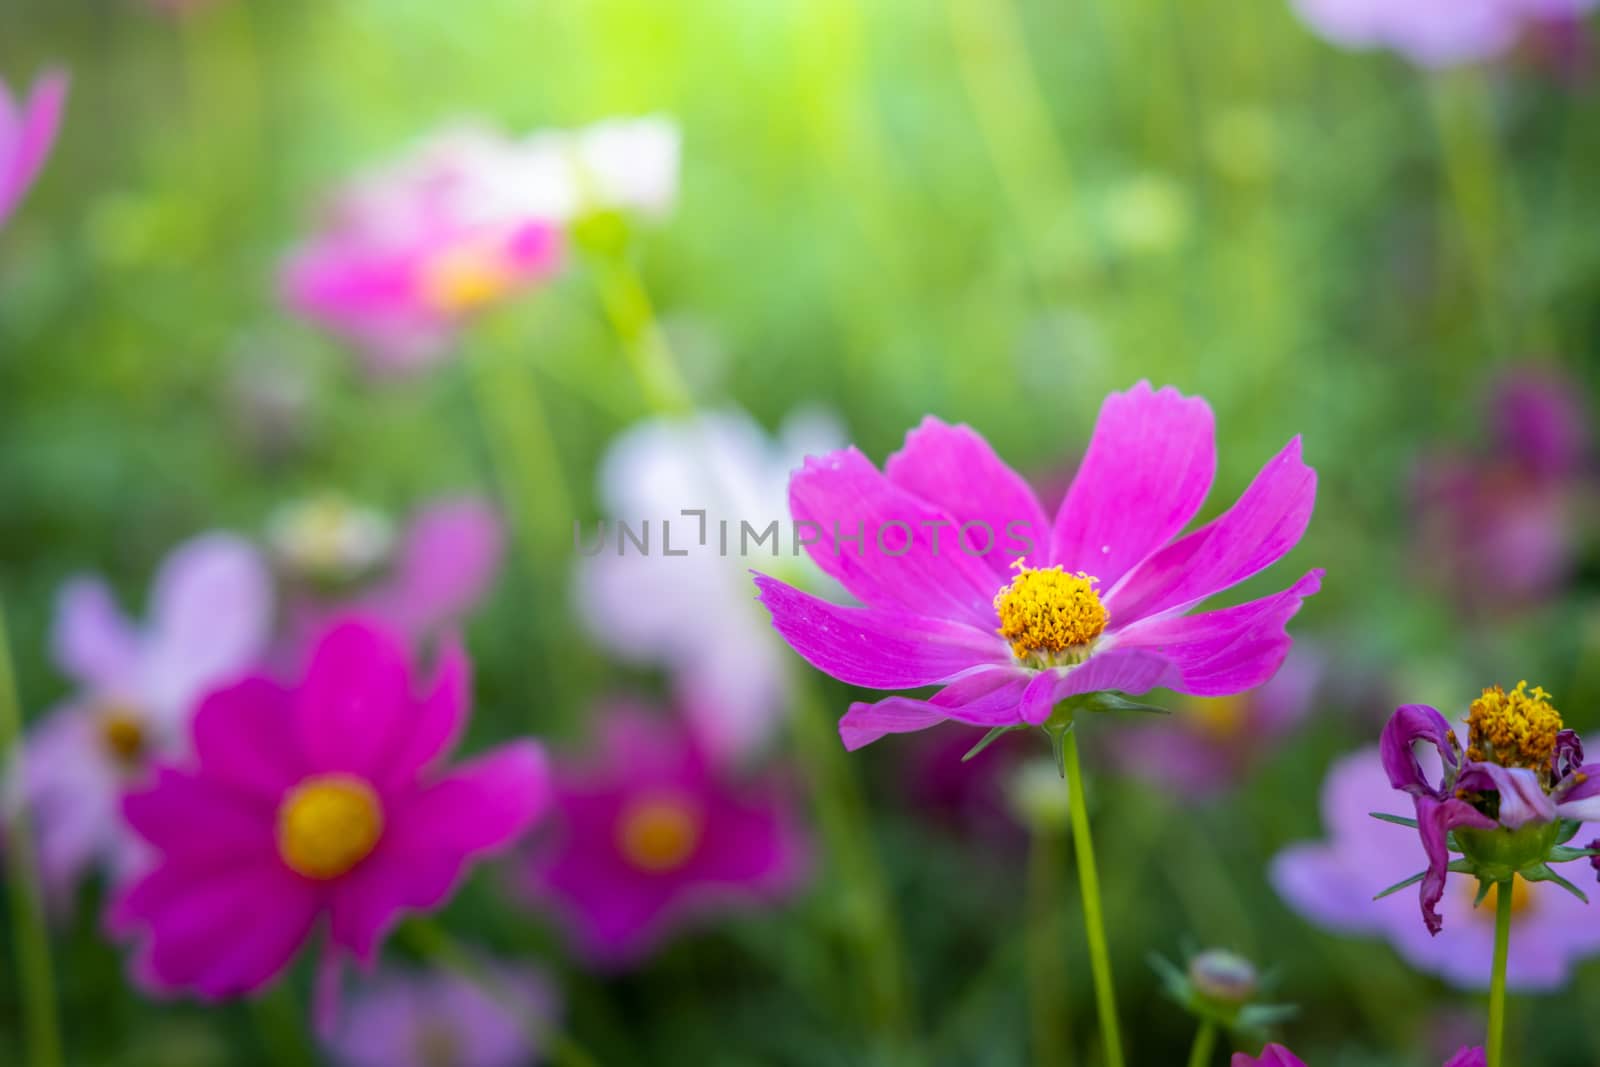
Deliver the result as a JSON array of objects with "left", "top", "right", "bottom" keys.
[{"left": 1106, "top": 437, "right": 1317, "bottom": 629}]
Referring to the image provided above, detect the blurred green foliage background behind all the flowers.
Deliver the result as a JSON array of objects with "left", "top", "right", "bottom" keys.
[{"left": 0, "top": 0, "right": 1600, "bottom": 1067}]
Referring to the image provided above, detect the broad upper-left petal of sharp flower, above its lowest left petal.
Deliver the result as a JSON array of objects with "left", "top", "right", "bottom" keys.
[{"left": 789, "top": 448, "right": 998, "bottom": 627}]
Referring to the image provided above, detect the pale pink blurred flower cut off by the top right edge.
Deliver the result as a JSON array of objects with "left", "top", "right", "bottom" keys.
[{"left": 1294, "top": 0, "right": 1597, "bottom": 67}]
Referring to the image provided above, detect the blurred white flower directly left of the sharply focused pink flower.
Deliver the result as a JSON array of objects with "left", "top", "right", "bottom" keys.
[{"left": 574, "top": 410, "right": 842, "bottom": 761}]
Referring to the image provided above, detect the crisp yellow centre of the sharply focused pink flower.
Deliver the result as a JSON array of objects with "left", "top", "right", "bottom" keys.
[{"left": 995, "top": 560, "right": 1110, "bottom": 667}]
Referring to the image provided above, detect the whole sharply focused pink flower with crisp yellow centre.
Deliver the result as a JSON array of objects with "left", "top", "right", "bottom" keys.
[{"left": 755, "top": 382, "right": 1322, "bottom": 749}]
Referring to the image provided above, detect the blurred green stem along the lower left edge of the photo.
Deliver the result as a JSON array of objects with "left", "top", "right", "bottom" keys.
[{"left": 0, "top": 603, "right": 62, "bottom": 1067}]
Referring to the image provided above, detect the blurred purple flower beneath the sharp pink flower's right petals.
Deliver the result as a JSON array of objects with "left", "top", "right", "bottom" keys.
[{"left": 1107, "top": 645, "right": 1323, "bottom": 801}]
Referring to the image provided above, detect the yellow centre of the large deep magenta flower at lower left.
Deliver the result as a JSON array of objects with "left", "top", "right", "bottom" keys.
[{"left": 278, "top": 774, "right": 384, "bottom": 880}]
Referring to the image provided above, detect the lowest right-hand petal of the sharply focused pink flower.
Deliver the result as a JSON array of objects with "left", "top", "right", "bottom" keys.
[{"left": 1115, "top": 569, "right": 1323, "bottom": 696}]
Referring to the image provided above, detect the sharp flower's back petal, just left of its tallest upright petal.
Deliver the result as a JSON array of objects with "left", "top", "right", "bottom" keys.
[{"left": 883, "top": 416, "right": 1050, "bottom": 589}]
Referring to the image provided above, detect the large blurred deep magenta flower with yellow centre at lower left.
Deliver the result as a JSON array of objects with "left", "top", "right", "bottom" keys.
[{"left": 109, "top": 619, "right": 549, "bottom": 1000}]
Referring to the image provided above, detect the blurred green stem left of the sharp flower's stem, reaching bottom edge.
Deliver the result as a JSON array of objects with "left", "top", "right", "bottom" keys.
[{"left": 789, "top": 683, "right": 917, "bottom": 1062}]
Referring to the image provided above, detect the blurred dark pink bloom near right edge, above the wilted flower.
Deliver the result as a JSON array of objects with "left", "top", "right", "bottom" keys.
[{"left": 1414, "top": 366, "right": 1592, "bottom": 611}]
